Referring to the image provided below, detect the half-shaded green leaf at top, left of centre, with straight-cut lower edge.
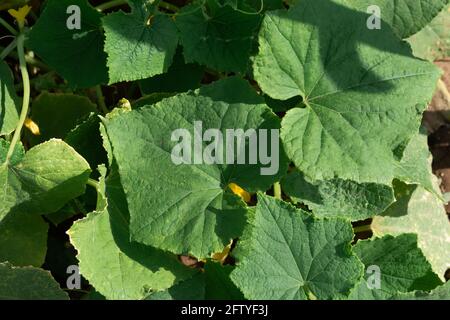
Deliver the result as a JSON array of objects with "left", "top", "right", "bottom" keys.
[{"left": 102, "top": 0, "right": 178, "bottom": 84}]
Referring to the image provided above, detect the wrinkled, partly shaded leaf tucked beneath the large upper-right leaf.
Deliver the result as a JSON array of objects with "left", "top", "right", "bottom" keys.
[{"left": 282, "top": 172, "right": 394, "bottom": 221}]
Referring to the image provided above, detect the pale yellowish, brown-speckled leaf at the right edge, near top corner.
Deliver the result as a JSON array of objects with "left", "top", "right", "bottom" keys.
[{"left": 408, "top": 6, "right": 450, "bottom": 61}]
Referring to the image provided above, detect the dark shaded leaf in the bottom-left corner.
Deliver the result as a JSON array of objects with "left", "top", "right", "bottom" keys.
[{"left": 0, "top": 263, "right": 68, "bottom": 300}]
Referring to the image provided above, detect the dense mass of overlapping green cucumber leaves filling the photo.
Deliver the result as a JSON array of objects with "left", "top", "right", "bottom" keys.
[{"left": 0, "top": 0, "right": 450, "bottom": 300}]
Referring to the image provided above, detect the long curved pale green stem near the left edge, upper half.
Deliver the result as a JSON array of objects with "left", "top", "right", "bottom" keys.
[{"left": 5, "top": 33, "right": 30, "bottom": 164}]
